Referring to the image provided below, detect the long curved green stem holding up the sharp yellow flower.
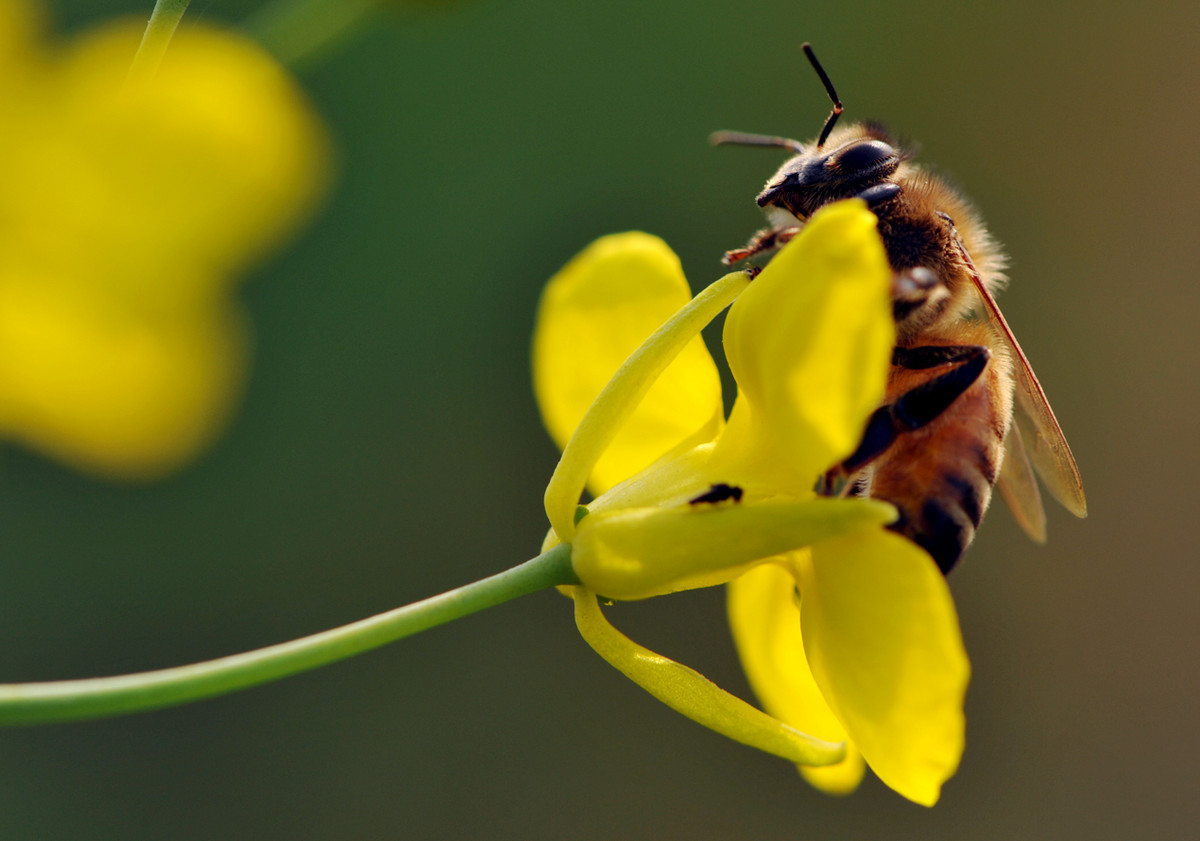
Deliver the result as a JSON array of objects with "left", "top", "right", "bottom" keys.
[{"left": 0, "top": 543, "right": 578, "bottom": 725}]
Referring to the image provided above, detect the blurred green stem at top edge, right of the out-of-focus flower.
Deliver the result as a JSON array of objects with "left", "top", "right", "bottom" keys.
[{"left": 242, "top": 0, "right": 382, "bottom": 68}]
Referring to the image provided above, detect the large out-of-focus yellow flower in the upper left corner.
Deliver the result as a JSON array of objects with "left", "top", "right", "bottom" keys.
[{"left": 0, "top": 0, "right": 326, "bottom": 477}]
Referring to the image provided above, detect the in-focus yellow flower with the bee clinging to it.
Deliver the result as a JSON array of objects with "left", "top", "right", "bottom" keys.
[{"left": 534, "top": 202, "right": 968, "bottom": 805}]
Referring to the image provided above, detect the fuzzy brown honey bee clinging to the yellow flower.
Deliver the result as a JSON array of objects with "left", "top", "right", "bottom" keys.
[{"left": 712, "top": 44, "right": 1087, "bottom": 572}]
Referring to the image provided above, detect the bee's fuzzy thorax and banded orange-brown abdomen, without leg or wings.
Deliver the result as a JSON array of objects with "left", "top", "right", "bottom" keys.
[{"left": 859, "top": 136, "right": 1015, "bottom": 571}]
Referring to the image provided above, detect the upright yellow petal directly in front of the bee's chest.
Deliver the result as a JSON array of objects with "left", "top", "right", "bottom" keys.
[{"left": 714, "top": 199, "right": 895, "bottom": 488}]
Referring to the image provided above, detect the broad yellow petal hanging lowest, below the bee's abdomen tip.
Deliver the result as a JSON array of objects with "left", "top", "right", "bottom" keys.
[{"left": 798, "top": 530, "right": 970, "bottom": 806}]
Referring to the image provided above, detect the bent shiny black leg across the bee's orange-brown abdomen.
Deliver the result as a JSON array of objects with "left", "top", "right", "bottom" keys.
[{"left": 817, "top": 344, "right": 991, "bottom": 495}]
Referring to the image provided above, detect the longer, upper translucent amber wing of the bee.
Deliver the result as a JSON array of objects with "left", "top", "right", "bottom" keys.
[{"left": 972, "top": 272, "right": 1087, "bottom": 515}]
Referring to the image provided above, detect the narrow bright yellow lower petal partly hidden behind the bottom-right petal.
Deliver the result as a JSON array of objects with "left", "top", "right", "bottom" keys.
[{"left": 728, "top": 564, "right": 863, "bottom": 794}]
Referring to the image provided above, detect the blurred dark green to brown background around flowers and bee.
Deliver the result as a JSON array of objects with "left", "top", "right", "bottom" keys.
[{"left": 0, "top": 0, "right": 1200, "bottom": 841}]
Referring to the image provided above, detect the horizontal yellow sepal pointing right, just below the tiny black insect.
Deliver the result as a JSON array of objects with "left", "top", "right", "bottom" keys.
[{"left": 571, "top": 499, "right": 895, "bottom": 600}]
